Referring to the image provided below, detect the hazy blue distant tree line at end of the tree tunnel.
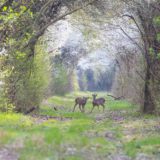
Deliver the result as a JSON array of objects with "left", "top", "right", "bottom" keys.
[{"left": 78, "top": 63, "right": 116, "bottom": 91}]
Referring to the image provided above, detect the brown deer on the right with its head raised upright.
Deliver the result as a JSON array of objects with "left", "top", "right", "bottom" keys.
[{"left": 91, "top": 94, "right": 106, "bottom": 113}]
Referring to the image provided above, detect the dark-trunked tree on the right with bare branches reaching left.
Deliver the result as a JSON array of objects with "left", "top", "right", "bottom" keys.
[{"left": 121, "top": 0, "right": 160, "bottom": 113}]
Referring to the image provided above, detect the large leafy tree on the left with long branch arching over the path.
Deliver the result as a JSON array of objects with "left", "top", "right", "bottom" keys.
[{"left": 0, "top": 0, "right": 97, "bottom": 112}]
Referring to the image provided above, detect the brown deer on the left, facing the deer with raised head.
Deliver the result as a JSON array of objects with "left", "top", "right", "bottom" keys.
[{"left": 73, "top": 97, "right": 89, "bottom": 112}]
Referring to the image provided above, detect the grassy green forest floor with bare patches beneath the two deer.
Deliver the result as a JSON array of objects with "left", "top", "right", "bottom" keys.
[{"left": 0, "top": 93, "right": 160, "bottom": 160}]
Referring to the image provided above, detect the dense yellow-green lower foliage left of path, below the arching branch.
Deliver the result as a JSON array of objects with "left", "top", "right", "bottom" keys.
[{"left": 1, "top": 42, "right": 50, "bottom": 112}]
